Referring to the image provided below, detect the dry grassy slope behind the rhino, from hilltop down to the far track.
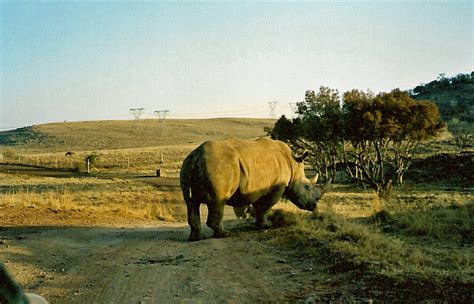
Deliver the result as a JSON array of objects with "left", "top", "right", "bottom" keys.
[{"left": 0, "top": 118, "right": 274, "bottom": 177}]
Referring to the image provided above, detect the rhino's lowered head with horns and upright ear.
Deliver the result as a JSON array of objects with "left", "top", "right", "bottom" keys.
[{"left": 286, "top": 151, "right": 331, "bottom": 211}]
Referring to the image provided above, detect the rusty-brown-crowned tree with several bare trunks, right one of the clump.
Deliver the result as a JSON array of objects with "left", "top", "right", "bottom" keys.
[{"left": 343, "top": 89, "right": 444, "bottom": 197}]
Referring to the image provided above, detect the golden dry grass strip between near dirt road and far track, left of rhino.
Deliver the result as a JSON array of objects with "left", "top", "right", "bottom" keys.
[{"left": 0, "top": 174, "right": 185, "bottom": 221}]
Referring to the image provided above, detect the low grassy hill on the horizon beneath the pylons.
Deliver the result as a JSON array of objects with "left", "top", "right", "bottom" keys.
[{"left": 0, "top": 118, "right": 274, "bottom": 153}]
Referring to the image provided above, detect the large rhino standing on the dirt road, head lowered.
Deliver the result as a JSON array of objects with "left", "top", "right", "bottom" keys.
[{"left": 180, "top": 138, "right": 330, "bottom": 241}]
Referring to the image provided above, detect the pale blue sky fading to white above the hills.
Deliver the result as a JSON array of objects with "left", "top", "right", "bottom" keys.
[{"left": 0, "top": 0, "right": 474, "bottom": 130}]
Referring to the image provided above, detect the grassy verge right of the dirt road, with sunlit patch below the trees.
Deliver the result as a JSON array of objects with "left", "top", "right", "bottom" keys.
[{"left": 270, "top": 189, "right": 474, "bottom": 299}]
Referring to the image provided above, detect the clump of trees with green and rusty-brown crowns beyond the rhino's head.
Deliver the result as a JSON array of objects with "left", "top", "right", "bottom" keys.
[{"left": 271, "top": 87, "right": 444, "bottom": 198}]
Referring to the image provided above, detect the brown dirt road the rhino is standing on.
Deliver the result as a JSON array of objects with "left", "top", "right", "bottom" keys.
[{"left": 0, "top": 167, "right": 333, "bottom": 303}]
